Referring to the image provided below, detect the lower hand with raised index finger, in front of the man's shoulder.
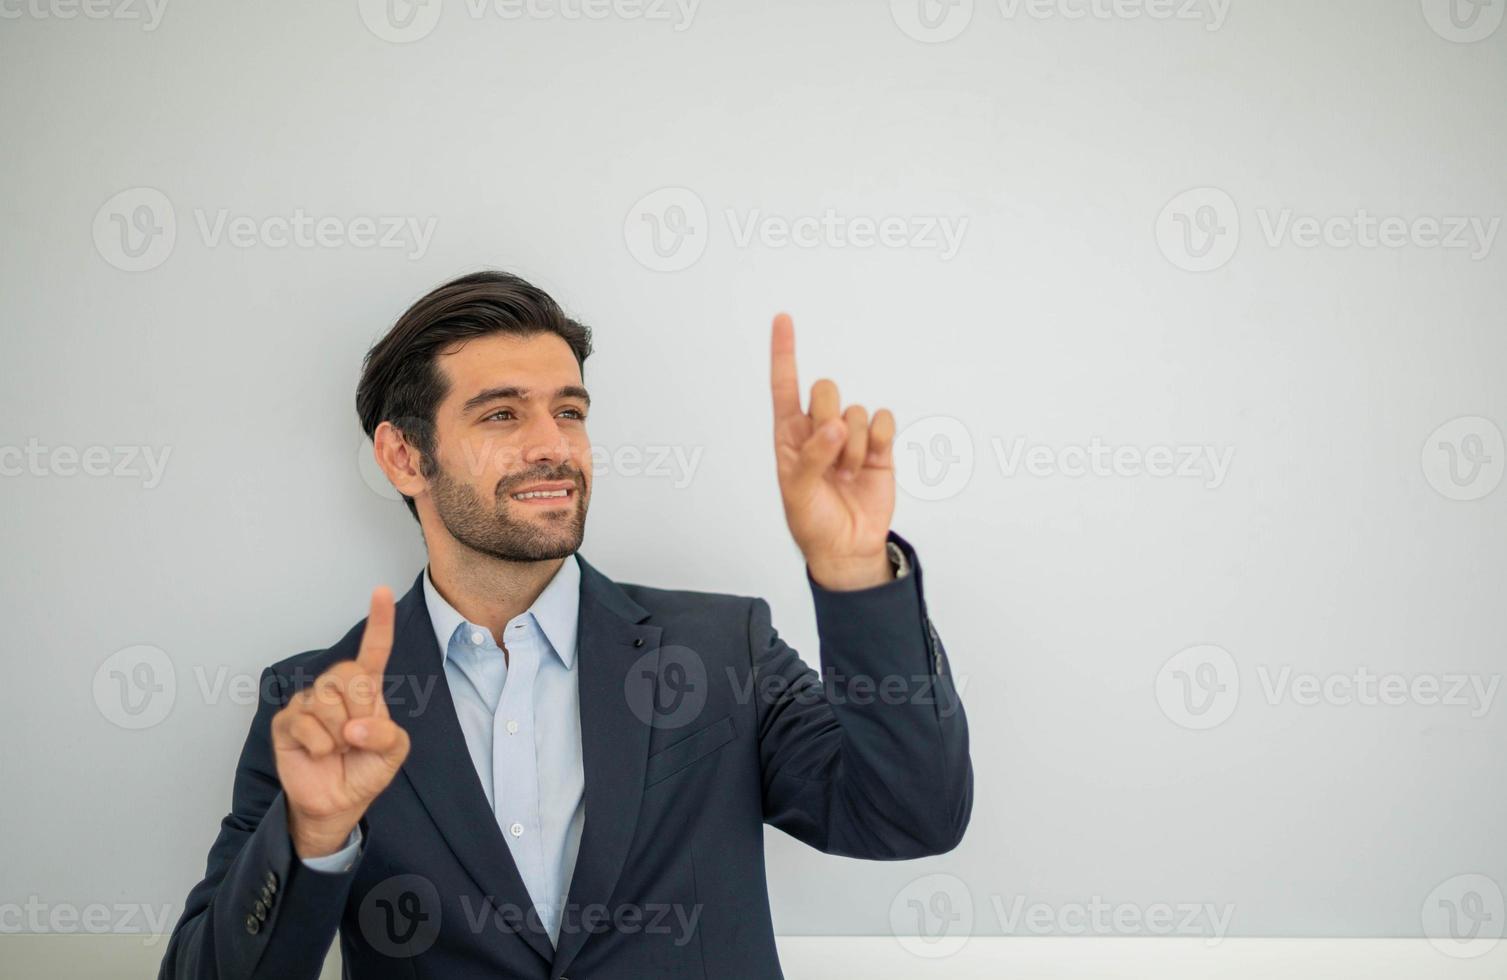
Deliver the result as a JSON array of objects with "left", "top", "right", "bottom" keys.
[{"left": 273, "top": 585, "right": 408, "bottom": 858}]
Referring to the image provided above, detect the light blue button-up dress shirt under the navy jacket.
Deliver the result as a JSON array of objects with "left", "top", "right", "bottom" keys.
[{"left": 304, "top": 555, "right": 586, "bottom": 942}]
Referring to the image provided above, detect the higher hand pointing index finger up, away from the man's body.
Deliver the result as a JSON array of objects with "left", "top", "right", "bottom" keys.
[{"left": 770, "top": 314, "right": 895, "bottom": 590}]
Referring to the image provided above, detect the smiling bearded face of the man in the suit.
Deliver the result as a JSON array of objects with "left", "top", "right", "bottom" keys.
[{"left": 426, "top": 333, "right": 591, "bottom": 561}]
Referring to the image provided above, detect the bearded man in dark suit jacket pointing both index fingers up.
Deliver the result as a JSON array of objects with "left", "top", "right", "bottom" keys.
[{"left": 161, "top": 273, "right": 974, "bottom": 980}]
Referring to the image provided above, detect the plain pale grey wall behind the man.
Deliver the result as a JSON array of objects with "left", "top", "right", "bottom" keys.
[{"left": 0, "top": 0, "right": 1507, "bottom": 936}]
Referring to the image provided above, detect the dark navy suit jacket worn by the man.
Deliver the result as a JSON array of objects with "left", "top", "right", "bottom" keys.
[{"left": 160, "top": 532, "right": 974, "bottom": 980}]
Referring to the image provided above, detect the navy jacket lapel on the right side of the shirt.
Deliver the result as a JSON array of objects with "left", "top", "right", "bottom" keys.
[{"left": 550, "top": 553, "right": 662, "bottom": 977}]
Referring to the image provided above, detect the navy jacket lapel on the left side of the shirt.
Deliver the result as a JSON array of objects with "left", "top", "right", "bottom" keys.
[{"left": 384, "top": 571, "right": 557, "bottom": 962}]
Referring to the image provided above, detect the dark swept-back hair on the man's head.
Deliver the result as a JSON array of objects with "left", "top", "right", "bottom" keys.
[{"left": 356, "top": 271, "right": 591, "bottom": 520}]
